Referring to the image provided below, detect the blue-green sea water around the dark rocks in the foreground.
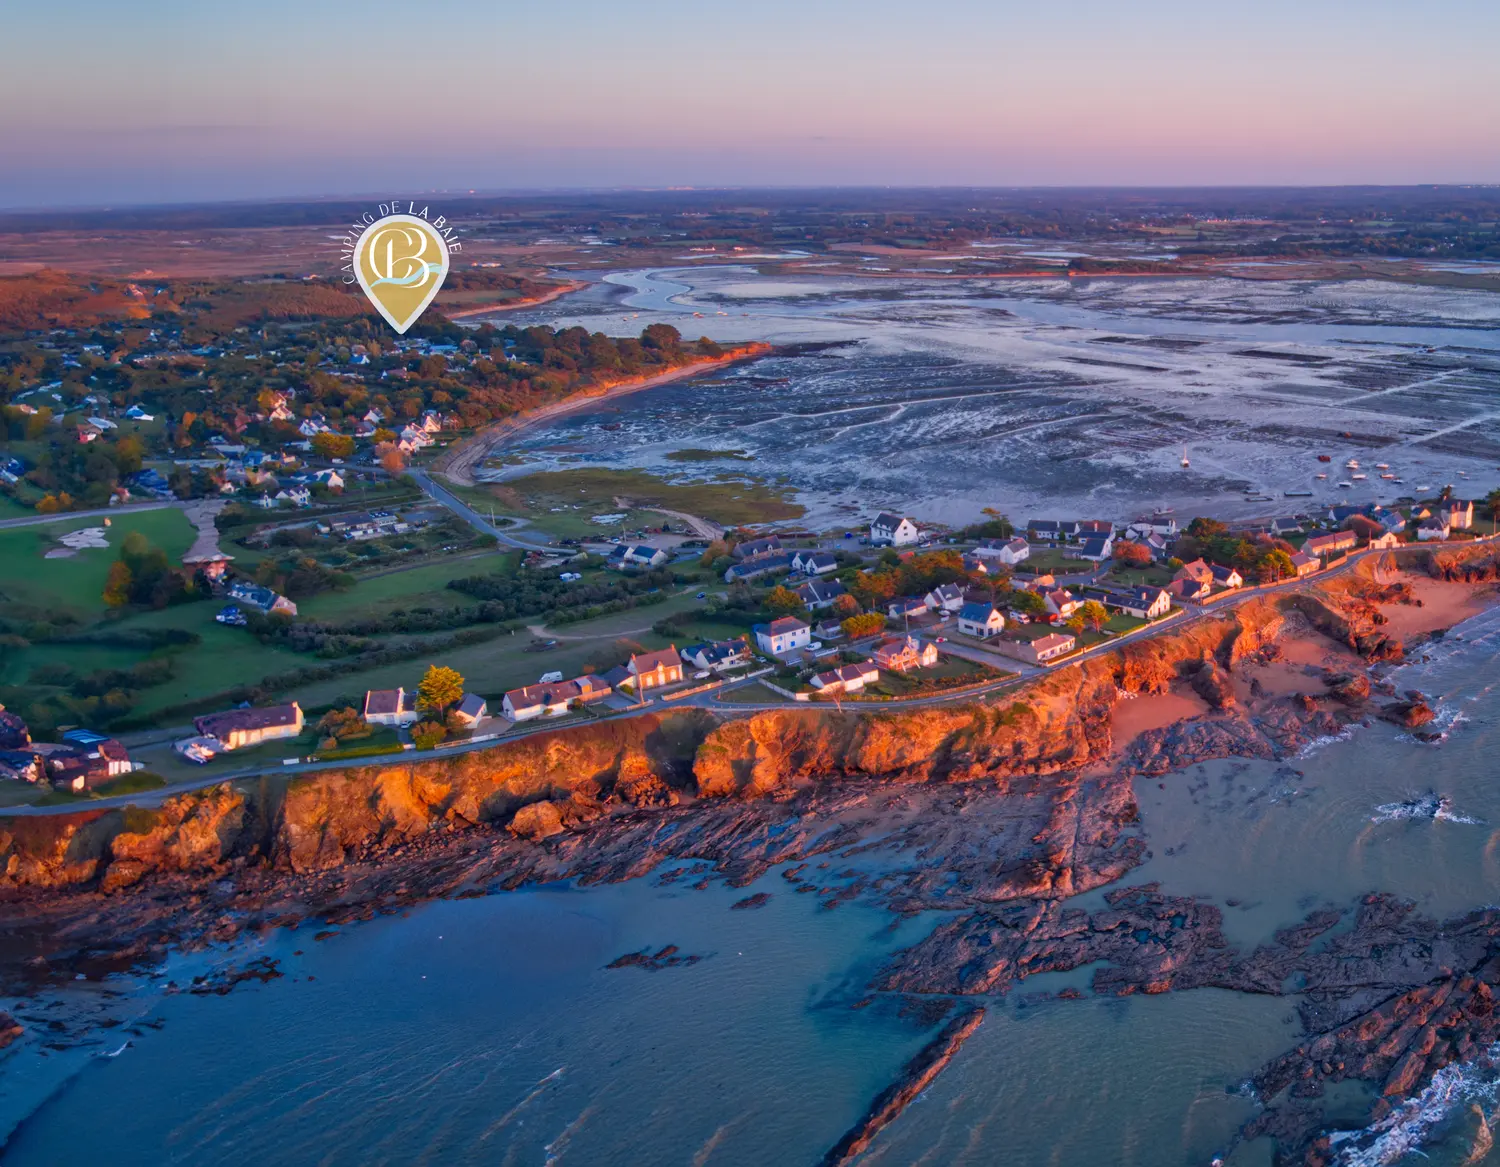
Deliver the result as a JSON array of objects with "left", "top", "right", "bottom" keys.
[{"left": 0, "top": 612, "right": 1500, "bottom": 1167}]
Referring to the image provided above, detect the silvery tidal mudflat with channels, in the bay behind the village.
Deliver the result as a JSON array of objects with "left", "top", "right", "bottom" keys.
[{"left": 485, "top": 267, "right": 1500, "bottom": 525}]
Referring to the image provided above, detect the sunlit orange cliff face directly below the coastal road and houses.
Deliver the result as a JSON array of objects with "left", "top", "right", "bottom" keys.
[{"left": 0, "top": 588, "right": 1314, "bottom": 897}]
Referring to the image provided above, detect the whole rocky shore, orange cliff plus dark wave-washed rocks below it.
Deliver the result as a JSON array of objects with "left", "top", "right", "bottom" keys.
[{"left": 0, "top": 552, "right": 1500, "bottom": 1164}]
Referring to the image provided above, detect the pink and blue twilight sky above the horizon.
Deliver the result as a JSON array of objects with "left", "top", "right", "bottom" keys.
[{"left": 0, "top": 0, "right": 1500, "bottom": 207}]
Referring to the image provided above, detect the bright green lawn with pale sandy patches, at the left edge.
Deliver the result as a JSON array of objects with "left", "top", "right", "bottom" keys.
[{"left": 0, "top": 507, "right": 194, "bottom": 617}]
